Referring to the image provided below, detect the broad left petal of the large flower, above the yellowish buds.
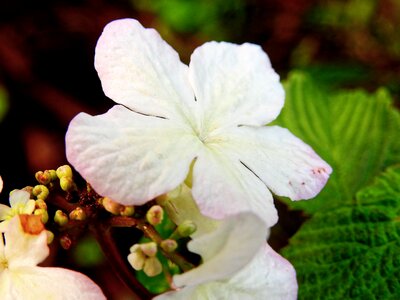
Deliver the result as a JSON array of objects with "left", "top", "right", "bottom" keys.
[{"left": 66, "top": 105, "right": 200, "bottom": 205}]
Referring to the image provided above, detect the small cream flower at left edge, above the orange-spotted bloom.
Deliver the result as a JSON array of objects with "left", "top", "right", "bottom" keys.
[{"left": 0, "top": 189, "right": 35, "bottom": 232}]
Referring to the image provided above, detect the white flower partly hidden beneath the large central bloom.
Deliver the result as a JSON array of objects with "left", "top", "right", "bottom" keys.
[{"left": 156, "top": 186, "right": 297, "bottom": 300}]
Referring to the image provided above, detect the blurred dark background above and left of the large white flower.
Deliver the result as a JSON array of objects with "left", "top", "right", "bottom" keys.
[{"left": 0, "top": 0, "right": 400, "bottom": 299}]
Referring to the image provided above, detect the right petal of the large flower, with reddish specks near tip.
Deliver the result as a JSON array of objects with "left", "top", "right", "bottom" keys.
[{"left": 224, "top": 126, "right": 332, "bottom": 200}]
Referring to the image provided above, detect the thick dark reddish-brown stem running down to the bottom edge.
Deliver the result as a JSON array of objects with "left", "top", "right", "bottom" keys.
[{"left": 90, "top": 224, "right": 154, "bottom": 300}]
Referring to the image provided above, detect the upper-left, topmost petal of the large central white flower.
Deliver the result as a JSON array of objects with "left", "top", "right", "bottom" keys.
[{"left": 95, "top": 19, "right": 195, "bottom": 121}]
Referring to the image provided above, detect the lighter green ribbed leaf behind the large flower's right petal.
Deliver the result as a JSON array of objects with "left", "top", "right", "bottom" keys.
[{"left": 275, "top": 72, "right": 400, "bottom": 213}]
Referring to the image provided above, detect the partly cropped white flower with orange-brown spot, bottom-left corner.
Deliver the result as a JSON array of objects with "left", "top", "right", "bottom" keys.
[{"left": 0, "top": 215, "right": 106, "bottom": 300}]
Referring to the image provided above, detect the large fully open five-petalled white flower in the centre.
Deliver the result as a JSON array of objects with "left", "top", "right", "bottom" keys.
[{"left": 66, "top": 19, "right": 331, "bottom": 225}]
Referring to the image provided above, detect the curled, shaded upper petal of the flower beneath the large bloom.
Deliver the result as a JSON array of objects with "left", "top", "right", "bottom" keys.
[{"left": 174, "top": 213, "right": 266, "bottom": 287}]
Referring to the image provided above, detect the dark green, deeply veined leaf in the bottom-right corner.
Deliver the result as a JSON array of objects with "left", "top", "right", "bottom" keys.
[{"left": 283, "top": 166, "right": 400, "bottom": 299}]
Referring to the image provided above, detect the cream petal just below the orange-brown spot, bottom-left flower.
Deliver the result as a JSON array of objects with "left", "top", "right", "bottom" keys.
[{"left": 4, "top": 216, "right": 49, "bottom": 268}]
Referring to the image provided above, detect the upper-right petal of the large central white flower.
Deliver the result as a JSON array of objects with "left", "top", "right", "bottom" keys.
[{"left": 189, "top": 42, "right": 284, "bottom": 131}]
